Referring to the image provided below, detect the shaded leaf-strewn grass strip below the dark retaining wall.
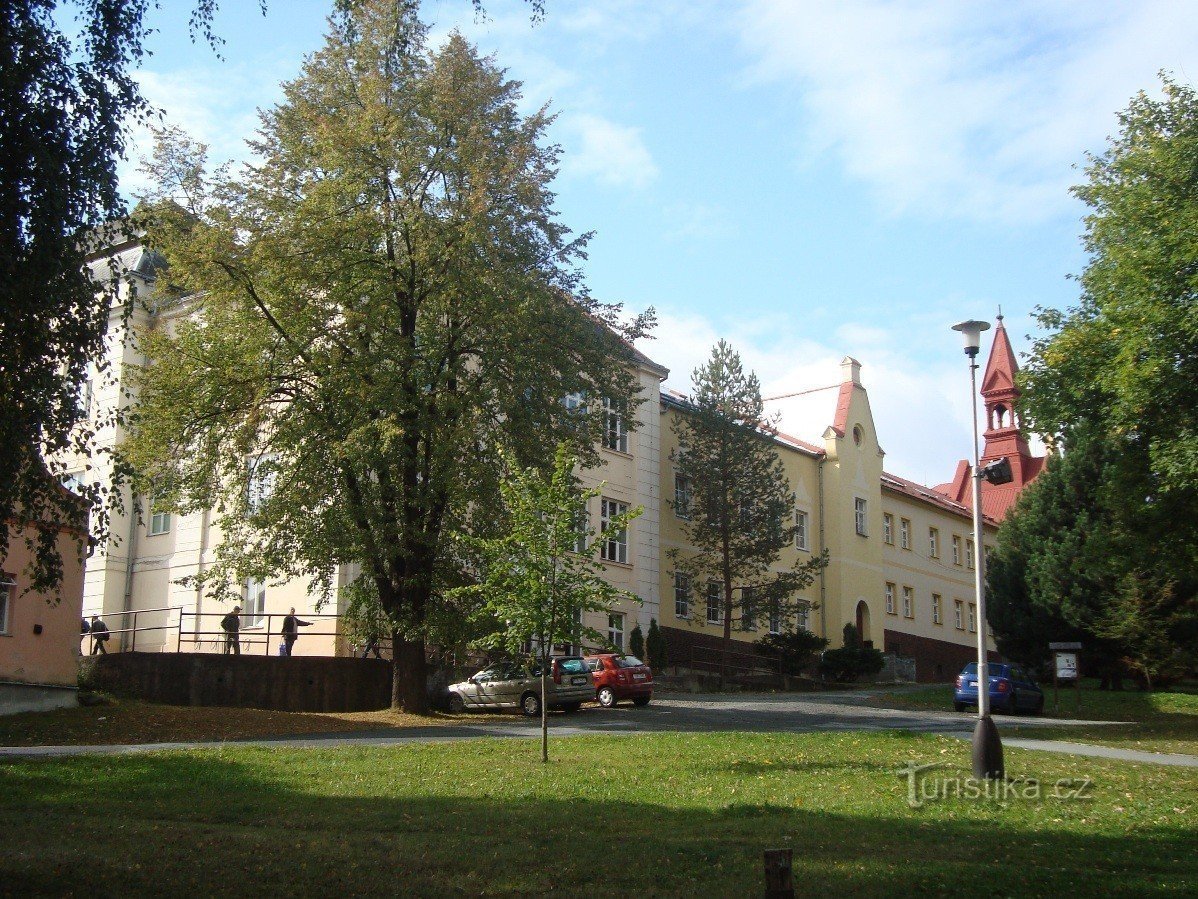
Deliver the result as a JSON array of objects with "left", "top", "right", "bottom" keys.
[{"left": 0, "top": 699, "right": 513, "bottom": 747}]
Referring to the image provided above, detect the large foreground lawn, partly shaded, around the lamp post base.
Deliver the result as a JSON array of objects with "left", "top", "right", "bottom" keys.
[{"left": 0, "top": 734, "right": 1198, "bottom": 895}]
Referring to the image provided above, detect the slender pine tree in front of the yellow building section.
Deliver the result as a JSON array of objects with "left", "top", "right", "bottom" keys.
[{"left": 670, "top": 340, "right": 827, "bottom": 680}]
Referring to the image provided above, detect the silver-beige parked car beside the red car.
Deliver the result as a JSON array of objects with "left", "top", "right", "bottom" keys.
[{"left": 449, "top": 656, "right": 595, "bottom": 718}]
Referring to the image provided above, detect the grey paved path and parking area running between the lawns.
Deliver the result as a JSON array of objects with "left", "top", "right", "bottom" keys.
[{"left": 0, "top": 693, "right": 1198, "bottom": 767}]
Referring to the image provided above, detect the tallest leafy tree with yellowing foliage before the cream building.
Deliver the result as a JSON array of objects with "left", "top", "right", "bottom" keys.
[{"left": 128, "top": 0, "right": 648, "bottom": 711}]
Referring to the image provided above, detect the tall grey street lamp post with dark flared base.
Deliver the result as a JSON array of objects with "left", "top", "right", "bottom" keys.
[{"left": 952, "top": 320, "right": 1010, "bottom": 779}]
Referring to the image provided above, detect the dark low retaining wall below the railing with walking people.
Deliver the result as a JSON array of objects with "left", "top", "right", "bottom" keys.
[{"left": 84, "top": 652, "right": 392, "bottom": 712}]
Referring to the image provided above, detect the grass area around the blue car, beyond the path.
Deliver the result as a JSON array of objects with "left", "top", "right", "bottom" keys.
[{"left": 870, "top": 680, "right": 1198, "bottom": 755}]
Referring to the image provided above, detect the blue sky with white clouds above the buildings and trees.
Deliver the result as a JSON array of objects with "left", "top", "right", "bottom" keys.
[{"left": 116, "top": 0, "right": 1198, "bottom": 484}]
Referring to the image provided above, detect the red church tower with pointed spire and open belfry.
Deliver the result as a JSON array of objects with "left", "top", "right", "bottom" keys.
[{"left": 936, "top": 313, "right": 1045, "bottom": 521}]
